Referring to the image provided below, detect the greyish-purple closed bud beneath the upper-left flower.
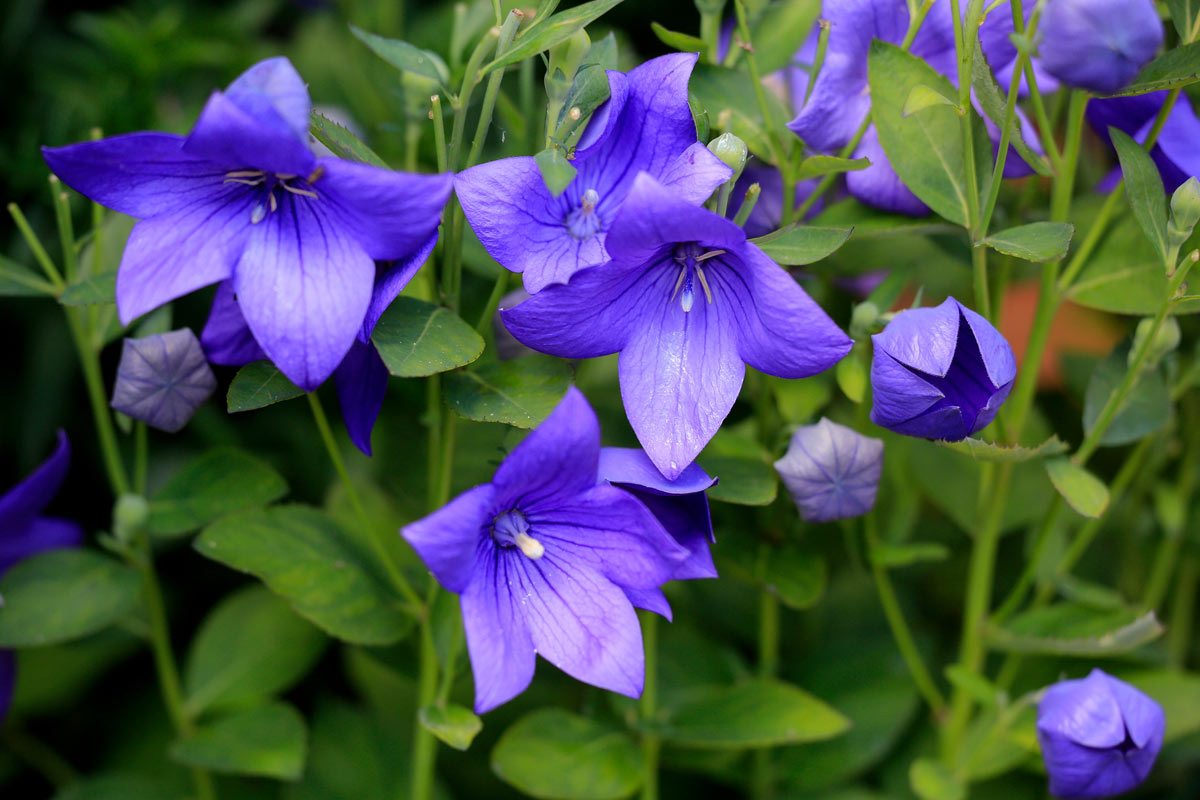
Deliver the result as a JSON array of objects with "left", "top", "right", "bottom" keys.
[{"left": 112, "top": 327, "right": 217, "bottom": 433}]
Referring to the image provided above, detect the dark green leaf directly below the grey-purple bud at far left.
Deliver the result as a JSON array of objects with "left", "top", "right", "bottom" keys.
[{"left": 146, "top": 447, "right": 288, "bottom": 536}]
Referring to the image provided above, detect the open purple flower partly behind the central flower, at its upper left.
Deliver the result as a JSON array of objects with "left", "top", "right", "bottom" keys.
[{"left": 455, "top": 53, "right": 732, "bottom": 294}]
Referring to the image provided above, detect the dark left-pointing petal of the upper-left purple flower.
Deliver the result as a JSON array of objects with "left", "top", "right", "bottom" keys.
[{"left": 42, "top": 133, "right": 226, "bottom": 218}]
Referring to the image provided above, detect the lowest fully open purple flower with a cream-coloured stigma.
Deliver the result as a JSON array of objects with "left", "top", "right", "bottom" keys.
[{"left": 401, "top": 387, "right": 688, "bottom": 714}]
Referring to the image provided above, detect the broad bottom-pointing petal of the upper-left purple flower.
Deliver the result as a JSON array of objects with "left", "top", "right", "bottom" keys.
[{"left": 229, "top": 194, "right": 376, "bottom": 391}]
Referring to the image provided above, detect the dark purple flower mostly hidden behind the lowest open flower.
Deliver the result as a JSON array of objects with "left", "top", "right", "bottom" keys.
[{"left": 600, "top": 447, "right": 718, "bottom": 619}]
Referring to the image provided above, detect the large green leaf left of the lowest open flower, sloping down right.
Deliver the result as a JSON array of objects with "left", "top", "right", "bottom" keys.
[{"left": 194, "top": 506, "right": 412, "bottom": 644}]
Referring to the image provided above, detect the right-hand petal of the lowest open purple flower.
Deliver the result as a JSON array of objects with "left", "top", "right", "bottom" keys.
[{"left": 526, "top": 479, "right": 689, "bottom": 589}]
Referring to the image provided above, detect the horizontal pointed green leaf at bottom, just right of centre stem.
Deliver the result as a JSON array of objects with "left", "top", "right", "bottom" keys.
[{"left": 662, "top": 679, "right": 850, "bottom": 748}]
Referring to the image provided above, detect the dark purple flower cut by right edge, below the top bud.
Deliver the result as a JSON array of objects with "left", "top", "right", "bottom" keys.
[{"left": 1087, "top": 90, "right": 1200, "bottom": 194}]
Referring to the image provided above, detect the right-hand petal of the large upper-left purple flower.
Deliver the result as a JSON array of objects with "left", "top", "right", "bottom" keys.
[{"left": 312, "top": 158, "right": 454, "bottom": 260}]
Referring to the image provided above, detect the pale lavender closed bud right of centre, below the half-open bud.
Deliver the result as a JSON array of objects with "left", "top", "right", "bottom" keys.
[{"left": 775, "top": 417, "right": 883, "bottom": 522}]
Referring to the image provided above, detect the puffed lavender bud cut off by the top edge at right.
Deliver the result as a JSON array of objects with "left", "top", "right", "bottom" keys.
[{"left": 1038, "top": 0, "right": 1163, "bottom": 94}]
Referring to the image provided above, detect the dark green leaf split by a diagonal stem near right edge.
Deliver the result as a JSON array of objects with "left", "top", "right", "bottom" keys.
[{"left": 1084, "top": 342, "right": 1171, "bottom": 447}]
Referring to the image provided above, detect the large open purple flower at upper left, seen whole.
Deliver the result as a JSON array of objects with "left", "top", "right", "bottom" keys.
[{"left": 42, "top": 58, "right": 452, "bottom": 390}]
